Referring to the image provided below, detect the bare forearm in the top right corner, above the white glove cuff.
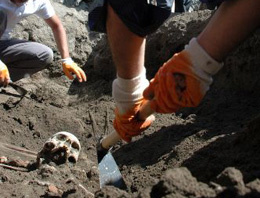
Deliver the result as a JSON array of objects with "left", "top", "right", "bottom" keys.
[{"left": 198, "top": 0, "right": 260, "bottom": 61}]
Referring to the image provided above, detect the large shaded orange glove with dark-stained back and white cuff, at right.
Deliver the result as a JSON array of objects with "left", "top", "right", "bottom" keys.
[{"left": 144, "top": 38, "right": 223, "bottom": 113}]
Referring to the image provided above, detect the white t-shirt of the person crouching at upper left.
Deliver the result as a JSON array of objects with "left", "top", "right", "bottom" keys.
[{"left": 0, "top": 0, "right": 55, "bottom": 40}]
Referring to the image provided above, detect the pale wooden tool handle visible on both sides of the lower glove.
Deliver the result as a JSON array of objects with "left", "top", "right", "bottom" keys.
[{"left": 101, "top": 101, "right": 154, "bottom": 149}]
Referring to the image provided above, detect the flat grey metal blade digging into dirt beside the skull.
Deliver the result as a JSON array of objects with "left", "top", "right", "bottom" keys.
[{"left": 98, "top": 151, "right": 126, "bottom": 189}]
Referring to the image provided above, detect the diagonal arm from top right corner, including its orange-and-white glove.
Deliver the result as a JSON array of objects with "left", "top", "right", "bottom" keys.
[{"left": 144, "top": 0, "right": 260, "bottom": 113}]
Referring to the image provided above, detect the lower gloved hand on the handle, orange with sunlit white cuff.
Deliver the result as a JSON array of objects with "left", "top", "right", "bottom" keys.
[{"left": 112, "top": 69, "right": 154, "bottom": 142}]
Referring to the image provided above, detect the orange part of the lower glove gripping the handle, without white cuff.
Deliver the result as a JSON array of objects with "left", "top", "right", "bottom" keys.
[{"left": 113, "top": 98, "right": 154, "bottom": 142}]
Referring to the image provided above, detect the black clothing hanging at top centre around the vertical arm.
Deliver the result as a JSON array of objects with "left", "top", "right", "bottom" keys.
[{"left": 89, "top": 0, "right": 173, "bottom": 37}]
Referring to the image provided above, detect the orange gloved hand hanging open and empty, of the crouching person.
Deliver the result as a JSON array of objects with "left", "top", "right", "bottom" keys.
[{"left": 62, "top": 58, "right": 87, "bottom": 82}]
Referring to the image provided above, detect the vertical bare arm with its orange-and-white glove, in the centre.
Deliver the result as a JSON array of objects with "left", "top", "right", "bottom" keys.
[{"left": 106, "top": 6, "right": 154, "bottom": 142}]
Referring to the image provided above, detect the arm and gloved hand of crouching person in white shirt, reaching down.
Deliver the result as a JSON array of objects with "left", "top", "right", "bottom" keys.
[{"left": 45, "top": 14, "right": 87, "bottom": 82}]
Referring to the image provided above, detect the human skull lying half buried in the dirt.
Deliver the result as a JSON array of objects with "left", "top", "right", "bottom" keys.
[{"left": 37, "top": 131, "right": 81, "bottom": 164}]
